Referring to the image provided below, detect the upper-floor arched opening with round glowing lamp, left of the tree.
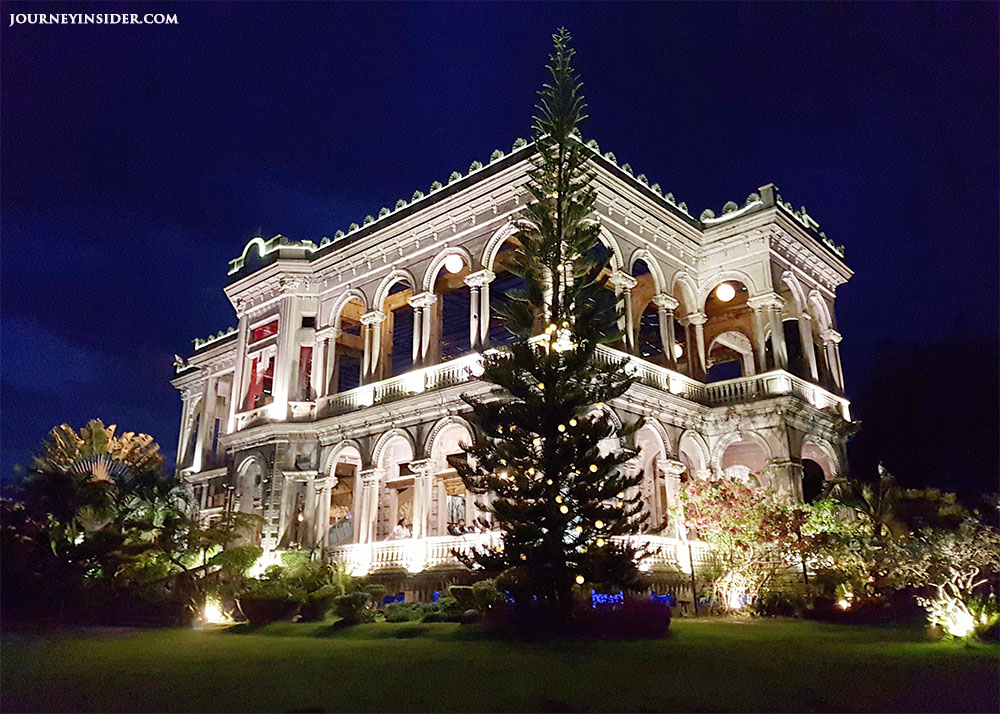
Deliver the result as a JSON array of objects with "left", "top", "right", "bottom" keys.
[{"left": 428, "top": 253, "right": 472, "bottom": 364}]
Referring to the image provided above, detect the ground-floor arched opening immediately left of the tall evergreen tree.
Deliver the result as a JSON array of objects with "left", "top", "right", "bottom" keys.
[{"left": 430, "top": 423, "right": 480, "bottom": 535}]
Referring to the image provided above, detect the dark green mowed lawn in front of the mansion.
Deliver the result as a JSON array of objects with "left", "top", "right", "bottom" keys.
[{"left": 0, "top": 619, "right": 1000, "bottom": 713}]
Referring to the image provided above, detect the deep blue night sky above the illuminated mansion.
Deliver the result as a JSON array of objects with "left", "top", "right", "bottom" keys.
[{"left": 0, "top": 2, "right": 1000, "bottom": 490}]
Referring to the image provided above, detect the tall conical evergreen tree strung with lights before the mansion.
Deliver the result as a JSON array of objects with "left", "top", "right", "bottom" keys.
[{"left": 455, "top": 29, "right": 646, "bottom": 618}]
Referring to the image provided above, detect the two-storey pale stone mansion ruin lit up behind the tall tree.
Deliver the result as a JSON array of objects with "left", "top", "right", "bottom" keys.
[{"left": 173, "top": 144, "right": 851, "bottom": 588}]
